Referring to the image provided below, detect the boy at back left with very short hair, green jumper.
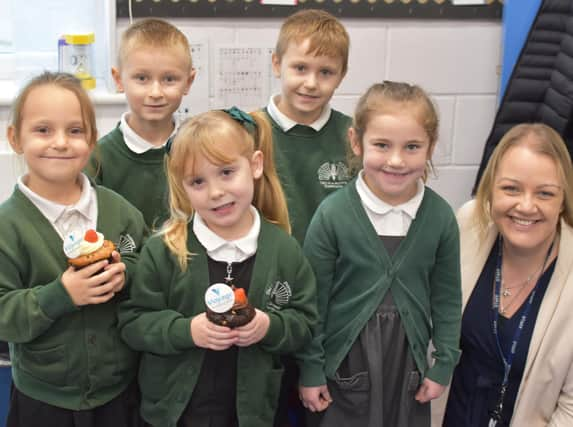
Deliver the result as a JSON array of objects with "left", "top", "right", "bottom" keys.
[{"left": 87, "top": 18, "right": 195, "bottom": 229}]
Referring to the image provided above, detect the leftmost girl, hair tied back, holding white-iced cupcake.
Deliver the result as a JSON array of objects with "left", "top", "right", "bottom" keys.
[{"left": 0, "top": 72, "right": 146, "bottom": 427}]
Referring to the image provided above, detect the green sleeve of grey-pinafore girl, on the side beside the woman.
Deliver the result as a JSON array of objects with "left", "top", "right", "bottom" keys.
[{"left": 426, "top": 213, "right": 462, "bottom": 385}]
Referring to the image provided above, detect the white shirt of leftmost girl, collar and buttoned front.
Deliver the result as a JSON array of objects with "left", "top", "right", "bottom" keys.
[{"left": 17, "top": 173, "right": 98, "bottom": 240}]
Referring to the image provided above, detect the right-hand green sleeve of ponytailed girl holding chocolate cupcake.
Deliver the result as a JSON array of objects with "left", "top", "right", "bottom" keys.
[{"left": 261, "top": 242, "right": 317, "bottom": 353}]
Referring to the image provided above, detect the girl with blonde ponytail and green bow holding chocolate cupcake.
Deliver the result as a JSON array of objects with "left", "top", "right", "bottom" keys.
[{"left": 120, "top": 107, "right": 317, "bottom": 427}]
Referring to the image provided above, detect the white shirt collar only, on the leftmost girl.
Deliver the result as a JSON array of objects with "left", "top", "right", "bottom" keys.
[{"left": 17, "top": 173, "right": 97, "bottom": 224}]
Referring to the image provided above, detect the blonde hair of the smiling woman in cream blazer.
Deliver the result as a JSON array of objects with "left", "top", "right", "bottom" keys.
[{"left": 476, "top": 123, "right": 573, "bottom": 232}]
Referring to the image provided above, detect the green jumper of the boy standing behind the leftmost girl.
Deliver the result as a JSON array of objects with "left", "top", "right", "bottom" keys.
[{"left": 86, "top": 125, "right": 169, "bottom": 230}]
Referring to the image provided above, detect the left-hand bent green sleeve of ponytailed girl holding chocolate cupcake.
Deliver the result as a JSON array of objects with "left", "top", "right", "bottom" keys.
[{"left": 119, "top": 237, "right": 195, "bottom": 355}]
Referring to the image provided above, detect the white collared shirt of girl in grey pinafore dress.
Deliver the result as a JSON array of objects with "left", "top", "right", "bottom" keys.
[{"left": 356, "top": 170, "right": 425, "bottom": 236}]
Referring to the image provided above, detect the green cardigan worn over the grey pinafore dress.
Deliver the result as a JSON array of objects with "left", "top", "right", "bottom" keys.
[{"left": 299, "top": 180, "right": 461, "bottom": 386}]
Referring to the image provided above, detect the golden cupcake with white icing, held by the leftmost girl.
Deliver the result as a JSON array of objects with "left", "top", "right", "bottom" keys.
[{"left": 64, "top": 229, "right": 115, "bottom": 268}]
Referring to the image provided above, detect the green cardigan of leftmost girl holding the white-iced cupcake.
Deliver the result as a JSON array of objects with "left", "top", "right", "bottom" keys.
[{"left": 0, "top": 187, "right": 145, "bottom": 410}]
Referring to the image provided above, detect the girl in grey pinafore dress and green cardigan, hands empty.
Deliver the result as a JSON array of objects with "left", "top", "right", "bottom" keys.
[{"left": 300, "top": 81, "right": 461, "bottom": 427}]
